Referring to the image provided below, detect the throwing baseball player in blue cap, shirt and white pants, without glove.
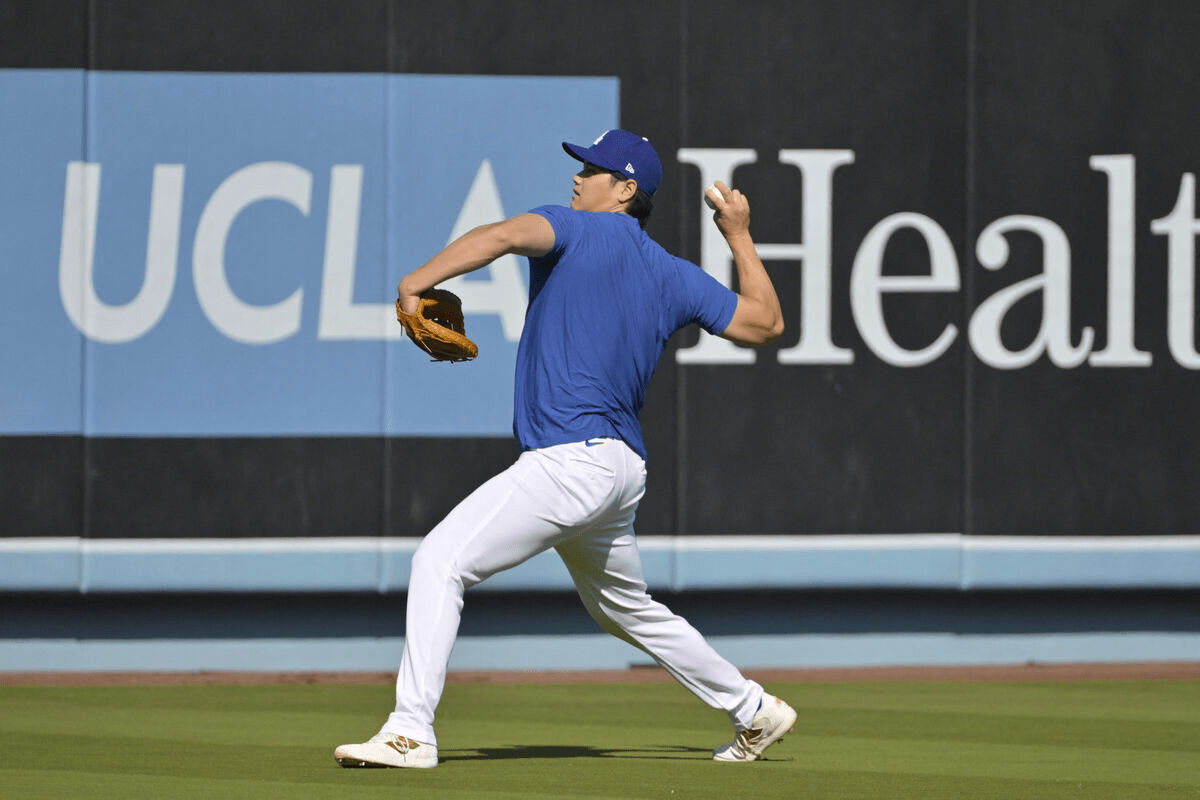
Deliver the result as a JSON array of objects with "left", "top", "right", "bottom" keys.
[{"left": 334, "top": 130, "right": 796, "bottom": 768}]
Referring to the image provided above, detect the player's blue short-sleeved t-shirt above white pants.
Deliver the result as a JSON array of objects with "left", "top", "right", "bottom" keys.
[{"left": 512, "top": 205, "right": 738, "bottom": 459}]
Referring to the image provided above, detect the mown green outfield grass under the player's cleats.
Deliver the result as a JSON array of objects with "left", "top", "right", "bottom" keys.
[{"left": 0, "top": 681, "right": 1200, "bottom": 800}]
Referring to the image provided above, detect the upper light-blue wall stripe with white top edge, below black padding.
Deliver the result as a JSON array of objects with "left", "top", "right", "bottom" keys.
[{"left": 0, "top": 534, "right": 1200, "bottom": 593}]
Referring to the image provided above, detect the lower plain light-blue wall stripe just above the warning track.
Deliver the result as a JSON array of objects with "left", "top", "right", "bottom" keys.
[{"left": 0, "top": 631, "right": 1200, "bottom": 672}]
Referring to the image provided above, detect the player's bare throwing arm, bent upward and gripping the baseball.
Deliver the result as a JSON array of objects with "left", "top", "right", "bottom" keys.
[{"left": 709, "top": 181, "right": 784, "bottom": 347}]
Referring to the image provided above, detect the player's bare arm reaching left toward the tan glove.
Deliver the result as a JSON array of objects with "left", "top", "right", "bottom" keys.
[{"left": 397, "top": 213, "right": 554, "bottom": 314}]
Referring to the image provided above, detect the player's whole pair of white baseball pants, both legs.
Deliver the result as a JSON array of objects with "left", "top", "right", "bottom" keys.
[{"left": 382, "top": 439, "right": 762, "bottom": 745}]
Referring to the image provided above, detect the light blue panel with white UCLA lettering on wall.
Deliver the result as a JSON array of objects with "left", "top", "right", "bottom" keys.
[{"left": 0, "top": 71, "right": 618, "bottom": 435}]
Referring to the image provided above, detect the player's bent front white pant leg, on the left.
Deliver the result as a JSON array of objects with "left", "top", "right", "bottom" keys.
[{"left": 383, "top": 444, "right": 614, "bottom": 745}]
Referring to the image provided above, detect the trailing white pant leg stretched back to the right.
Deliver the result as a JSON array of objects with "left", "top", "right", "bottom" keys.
[{"left": 556, "top": 445, "right": 763, "bottom": 730}]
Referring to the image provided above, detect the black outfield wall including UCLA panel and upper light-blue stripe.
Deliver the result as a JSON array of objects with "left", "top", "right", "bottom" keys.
[{"left": 0, "top": 0, "right": 1200, "bottom": 671}]
